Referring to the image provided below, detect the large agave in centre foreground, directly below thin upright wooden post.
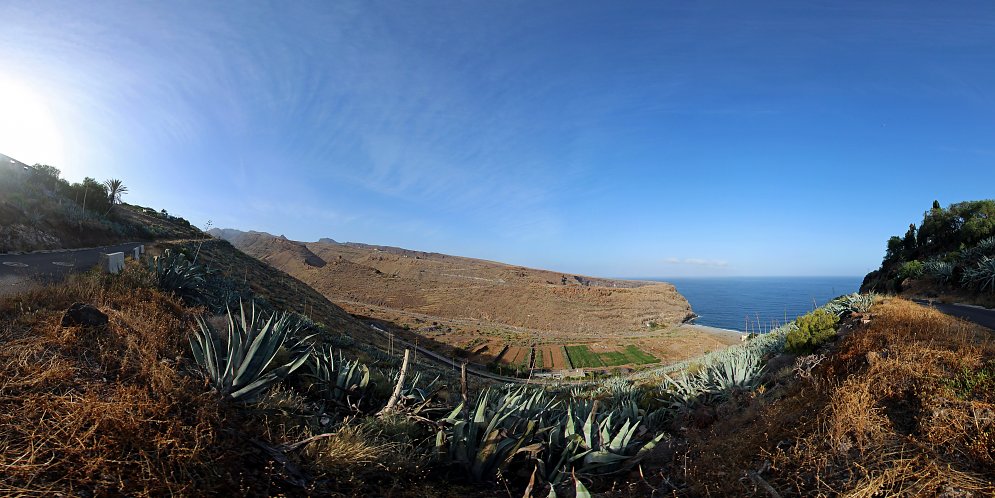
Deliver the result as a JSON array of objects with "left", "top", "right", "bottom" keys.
[{"left": 436, "top": 387, "right": 556, "bottom": 481}]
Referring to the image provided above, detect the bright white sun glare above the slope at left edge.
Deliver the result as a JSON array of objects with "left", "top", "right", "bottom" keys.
[{"left": 0, "top": 76, "right": 66, "bottom": 169}]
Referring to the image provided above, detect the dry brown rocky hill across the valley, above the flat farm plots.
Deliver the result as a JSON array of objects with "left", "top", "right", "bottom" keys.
[{"left": 211, "top": 230, "right": 693, "bottom": 344}]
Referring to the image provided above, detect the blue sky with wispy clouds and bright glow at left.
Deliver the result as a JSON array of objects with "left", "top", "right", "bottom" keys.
[{"left": 0, "top": 1, "right": 995, "bottom": 276}]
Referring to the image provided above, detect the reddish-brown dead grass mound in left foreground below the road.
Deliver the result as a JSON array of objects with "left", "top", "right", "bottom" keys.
[{"left": 0, "top": 268, "right": 274, "bottom": 496}]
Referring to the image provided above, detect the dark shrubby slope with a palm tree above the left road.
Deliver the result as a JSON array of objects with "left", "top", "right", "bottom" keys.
[{"left": 0, "top": 154, "right": 204, "bottom": 253}]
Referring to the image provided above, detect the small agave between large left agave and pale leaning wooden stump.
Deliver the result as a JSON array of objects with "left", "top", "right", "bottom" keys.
[{"left": 306, "top": 345, "right": 370, "bottom": 405}]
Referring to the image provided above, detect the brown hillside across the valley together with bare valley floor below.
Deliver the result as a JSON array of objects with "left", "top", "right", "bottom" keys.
[{"left": 211, "top": 230, "right": 738, "bottom": 369}]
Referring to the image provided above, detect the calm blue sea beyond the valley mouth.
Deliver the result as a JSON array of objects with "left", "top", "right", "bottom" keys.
[{"left": 648, "top": 277, "right": 862, "bottom": 331}]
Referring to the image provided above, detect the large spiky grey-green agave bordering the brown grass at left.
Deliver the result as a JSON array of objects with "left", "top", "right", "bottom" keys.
[{"left": 190, "top": 303, "right": 311, "bottom": 401}]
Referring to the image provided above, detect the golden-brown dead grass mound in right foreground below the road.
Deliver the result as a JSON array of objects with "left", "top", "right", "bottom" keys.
[{"left": 675, "top": 299, "right": 995, "bottom": 496}]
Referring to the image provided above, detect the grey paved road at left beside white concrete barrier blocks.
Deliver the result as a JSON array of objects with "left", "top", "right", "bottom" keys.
[{"left": 0, "top": 242, "right": 142, "bottom": 286}]
